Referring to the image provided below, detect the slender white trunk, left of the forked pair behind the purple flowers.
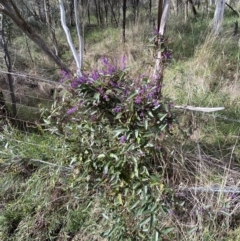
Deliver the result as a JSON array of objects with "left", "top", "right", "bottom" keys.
[{"left": 59, "top": 0, "right": 82, "bottom": 76}]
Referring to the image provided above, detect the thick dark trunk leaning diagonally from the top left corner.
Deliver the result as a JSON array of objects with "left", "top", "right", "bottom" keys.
[{"left": 0, "top": 0, "right": 71, "bottom": 73}]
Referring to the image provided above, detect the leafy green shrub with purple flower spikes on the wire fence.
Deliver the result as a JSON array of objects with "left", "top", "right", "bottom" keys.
[{"left": 46, "top": 58, "right": 176, "bottom": 240}]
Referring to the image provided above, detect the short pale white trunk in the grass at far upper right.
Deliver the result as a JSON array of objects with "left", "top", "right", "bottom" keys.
[{"left": 213, "top": 0, "right": 225, "bottom": 34}]
